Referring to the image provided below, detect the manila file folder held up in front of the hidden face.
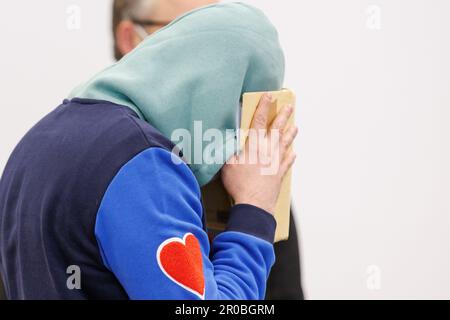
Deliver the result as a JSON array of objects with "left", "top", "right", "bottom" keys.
[{"left": 202, "top": 89, "right": 296, "bottom": 242}]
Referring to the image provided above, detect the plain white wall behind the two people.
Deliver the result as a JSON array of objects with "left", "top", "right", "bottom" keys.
[{"left": 0, "top": 0, "right": 450, "bottom": 299}]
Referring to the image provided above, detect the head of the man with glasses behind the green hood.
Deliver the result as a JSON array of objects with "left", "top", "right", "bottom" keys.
[{"left": 113, "top": 0, "right": 218, "bottom": 60}]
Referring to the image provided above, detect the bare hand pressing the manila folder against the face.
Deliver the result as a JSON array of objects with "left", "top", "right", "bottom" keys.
[{"left": 222, "top": 94, "right": 298, "bottom": 214}]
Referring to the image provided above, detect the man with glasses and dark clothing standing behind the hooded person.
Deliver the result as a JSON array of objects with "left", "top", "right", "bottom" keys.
[{"left": 113, "top": 0, "right": 303, "bottom": 300}]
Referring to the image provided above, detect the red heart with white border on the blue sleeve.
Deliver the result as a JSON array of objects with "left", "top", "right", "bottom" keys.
[{"left": 157, "top": 233, "right": 205, "bottom": 300}]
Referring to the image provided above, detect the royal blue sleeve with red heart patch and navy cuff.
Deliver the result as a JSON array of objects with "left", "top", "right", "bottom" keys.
[{"left": 95, "top": 148, "right": 276, "bottom": 300}]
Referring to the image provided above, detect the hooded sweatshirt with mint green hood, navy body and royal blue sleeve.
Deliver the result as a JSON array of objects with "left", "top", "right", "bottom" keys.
[{"left": 0, "top": 4, "right": 283, "bottom": 299}]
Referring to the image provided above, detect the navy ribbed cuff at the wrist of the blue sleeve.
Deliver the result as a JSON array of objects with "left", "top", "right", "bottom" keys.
[{"left": 226, "top": 204, "right": 277, "bottom": 243}]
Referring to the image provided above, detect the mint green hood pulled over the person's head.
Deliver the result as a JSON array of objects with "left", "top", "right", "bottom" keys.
[{"left": 70, "top": 3, "right": 284, "bottom": 185}]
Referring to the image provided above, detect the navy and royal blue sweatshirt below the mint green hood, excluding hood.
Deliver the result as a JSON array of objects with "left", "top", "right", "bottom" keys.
[{"left": 0, "top": 98, "right": 275, "bottom": 299}]
